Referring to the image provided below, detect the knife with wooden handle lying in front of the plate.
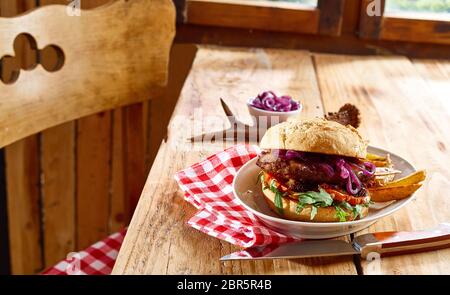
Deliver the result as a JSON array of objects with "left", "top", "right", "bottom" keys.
[{"left": 220, "top": 223, "right": 450, "bottom": 261}]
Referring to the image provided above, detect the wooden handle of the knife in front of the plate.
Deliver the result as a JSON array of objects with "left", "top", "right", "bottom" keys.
[{"left": 353, "top": 223, "right": 450, "bottom": 259}]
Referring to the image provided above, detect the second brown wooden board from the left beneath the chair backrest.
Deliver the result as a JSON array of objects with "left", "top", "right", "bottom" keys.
[{"left": 40, "top": 122, "right": 76, "bottom": 265}]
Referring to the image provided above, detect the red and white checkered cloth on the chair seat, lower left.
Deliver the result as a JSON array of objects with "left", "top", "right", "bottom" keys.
[{"left": 42, "top": 230, "right": 126, "bottom": 275}]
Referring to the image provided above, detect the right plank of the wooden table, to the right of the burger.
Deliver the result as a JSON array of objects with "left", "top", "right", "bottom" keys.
[{"left": 315, "top": 55, "right": 450, "bottom": 274}]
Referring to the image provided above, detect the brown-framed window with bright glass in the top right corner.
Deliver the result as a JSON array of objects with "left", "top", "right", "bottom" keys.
[{"left": 360, "top": 0, "right": 450, "bottom": 44}]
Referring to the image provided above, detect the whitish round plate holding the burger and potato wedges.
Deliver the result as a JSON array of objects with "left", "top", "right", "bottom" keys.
[{"left": 233, "top": 147, "right": 416, "bottom": 239}]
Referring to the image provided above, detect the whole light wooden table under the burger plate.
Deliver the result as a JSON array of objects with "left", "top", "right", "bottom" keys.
[{"left": 113, "top": 47, "right": 450, "bottom": 274}]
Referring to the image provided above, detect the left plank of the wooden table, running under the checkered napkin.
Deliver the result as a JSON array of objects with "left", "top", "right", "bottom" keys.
[{"left": 113, "top": 48, "right": 356, "bottom": 274}]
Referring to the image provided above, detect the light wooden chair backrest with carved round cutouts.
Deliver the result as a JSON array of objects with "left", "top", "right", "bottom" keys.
[{"left": 0, "top": 0, "right": 175, "bottom": 274}]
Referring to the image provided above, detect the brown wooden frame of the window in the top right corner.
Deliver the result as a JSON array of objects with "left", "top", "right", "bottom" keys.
[{"left": 359, "top": 0, "right": 450, "bottom": 45}]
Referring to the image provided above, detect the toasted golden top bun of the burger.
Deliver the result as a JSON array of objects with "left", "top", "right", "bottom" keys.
[{"left": 260, "top": 119, "right": 368, "bottom": 158}]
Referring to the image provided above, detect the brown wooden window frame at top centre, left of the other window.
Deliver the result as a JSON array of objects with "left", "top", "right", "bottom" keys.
[{"left": 184, "top": 0, "right": 345, "bottom": 36}]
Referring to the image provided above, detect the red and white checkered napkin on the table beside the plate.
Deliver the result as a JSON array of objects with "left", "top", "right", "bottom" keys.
[{"left": 175, "top": 145, "right": 295, "bottom": 248}]
